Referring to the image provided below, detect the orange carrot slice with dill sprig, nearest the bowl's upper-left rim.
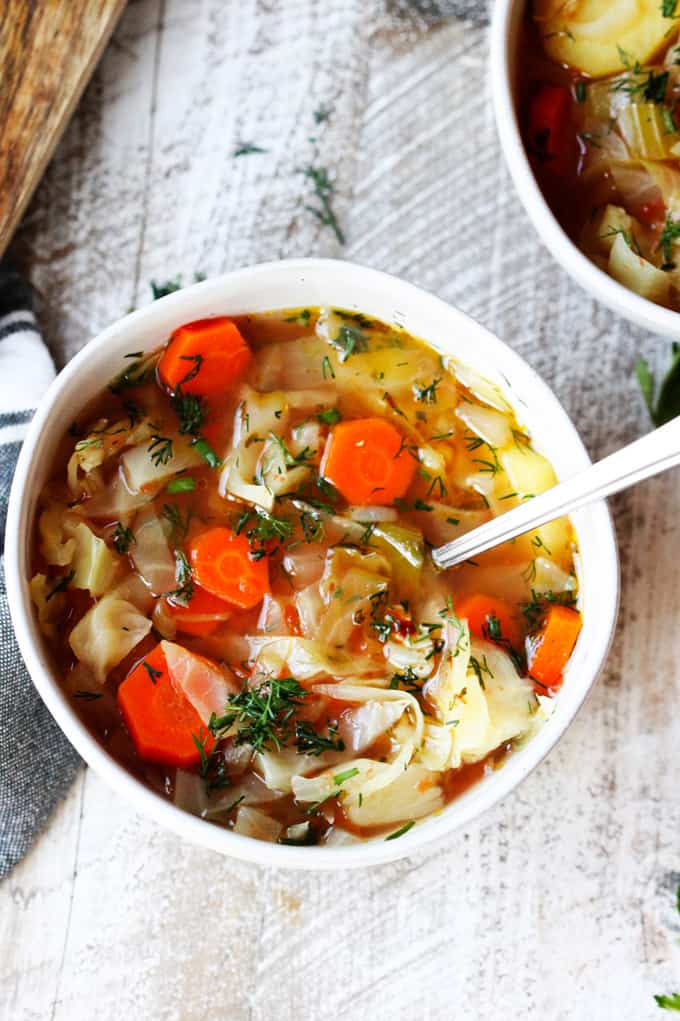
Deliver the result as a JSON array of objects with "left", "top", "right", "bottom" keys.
[{"left": 158, "top": 315, "right": 252, "bottom": 397}]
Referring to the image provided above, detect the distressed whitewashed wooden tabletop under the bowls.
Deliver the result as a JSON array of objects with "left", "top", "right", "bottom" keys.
[{"left": 0, "top": 0, "right": 680, "bottom": 1021}]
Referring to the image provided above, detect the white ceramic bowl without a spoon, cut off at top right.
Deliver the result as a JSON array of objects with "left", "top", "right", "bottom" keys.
[{"left": 490, "top": 0, "right": 680, "bottom": 340}]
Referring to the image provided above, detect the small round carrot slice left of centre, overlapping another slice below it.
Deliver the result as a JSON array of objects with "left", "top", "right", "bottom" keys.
[{"left": 189, "top": 528, "right": 270, "bottom": 610}]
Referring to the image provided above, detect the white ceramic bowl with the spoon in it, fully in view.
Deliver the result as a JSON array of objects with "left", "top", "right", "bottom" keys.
[{"left": 5, "top": 259, "right": 619, "bottom": 869}]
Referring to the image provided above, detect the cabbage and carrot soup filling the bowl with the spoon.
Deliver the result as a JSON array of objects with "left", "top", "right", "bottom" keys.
[{"left": 31, "top": 308, "right": 581, "bottom": 845}]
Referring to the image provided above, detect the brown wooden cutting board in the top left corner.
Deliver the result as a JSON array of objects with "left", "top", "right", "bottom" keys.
[{"left": 0, "top": 0, "right": 126, "bottom": 256}]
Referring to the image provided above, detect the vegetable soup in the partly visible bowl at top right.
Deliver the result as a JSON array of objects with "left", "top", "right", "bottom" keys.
[{"left": 518, "top": 0, "right": 680, "bottom": 309}]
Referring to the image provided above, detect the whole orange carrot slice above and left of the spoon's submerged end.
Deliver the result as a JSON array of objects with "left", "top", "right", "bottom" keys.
[{"left": 321, "top": 419, "right": 417, "bottom": 505}]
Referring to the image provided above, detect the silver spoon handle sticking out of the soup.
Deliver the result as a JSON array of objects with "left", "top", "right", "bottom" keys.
[{"left": 432, "top": 416, "right": 680, "bottom": 568}]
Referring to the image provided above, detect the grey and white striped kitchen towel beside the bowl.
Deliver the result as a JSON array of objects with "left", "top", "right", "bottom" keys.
[{"left": 0, "top": 268, "right": 80, "bottom": 878}]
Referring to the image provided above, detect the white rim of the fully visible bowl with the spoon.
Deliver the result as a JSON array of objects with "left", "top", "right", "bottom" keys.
[{"left": 5, "top": 258, "right": 619, "bottom": 870}]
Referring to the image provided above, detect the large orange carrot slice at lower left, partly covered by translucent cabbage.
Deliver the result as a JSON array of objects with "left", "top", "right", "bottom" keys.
[{"left": 118, "top": 645, "right": 213, "bottom": 769}]
